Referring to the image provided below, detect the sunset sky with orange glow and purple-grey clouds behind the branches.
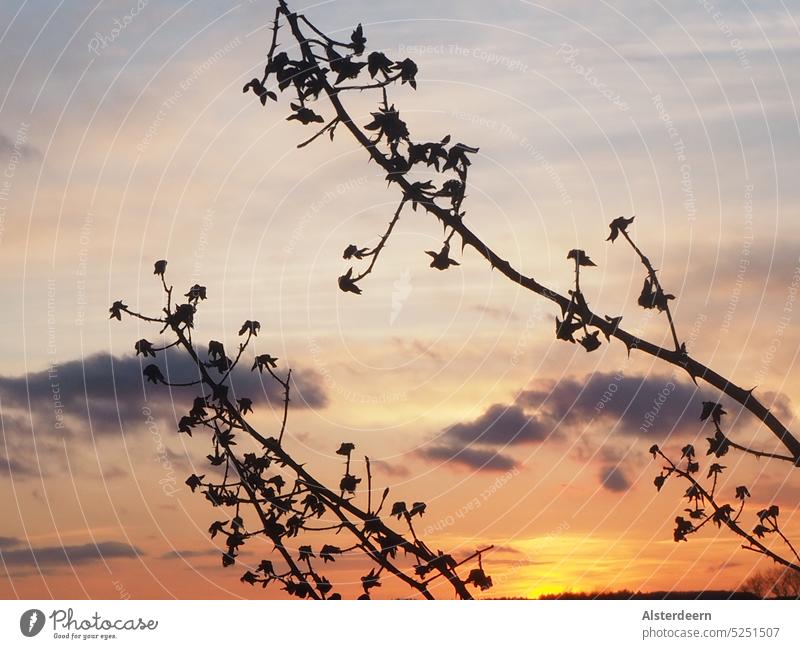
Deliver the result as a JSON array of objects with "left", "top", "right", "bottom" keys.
[{"left": 0, "top": 0, "right": 800, "bottom": 598}]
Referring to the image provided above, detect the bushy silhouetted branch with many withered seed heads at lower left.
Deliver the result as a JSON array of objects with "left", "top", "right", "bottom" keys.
[{"left": 109, "top": 260, "right": 492, "bottom": 599}]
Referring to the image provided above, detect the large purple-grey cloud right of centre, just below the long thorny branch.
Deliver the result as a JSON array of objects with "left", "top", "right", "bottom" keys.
[{"left": 418, "top": 372, "right": 792, "bottom": 476}]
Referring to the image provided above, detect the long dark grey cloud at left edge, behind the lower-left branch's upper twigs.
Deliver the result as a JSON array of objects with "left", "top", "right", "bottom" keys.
[{"left": 0, "top": 350, "right": 327, "bottom": 476}]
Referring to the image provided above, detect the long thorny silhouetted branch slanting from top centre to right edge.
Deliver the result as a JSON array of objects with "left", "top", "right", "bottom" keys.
[{"left": 244, "top": 0, "right": 800, "bottom": 565}]
